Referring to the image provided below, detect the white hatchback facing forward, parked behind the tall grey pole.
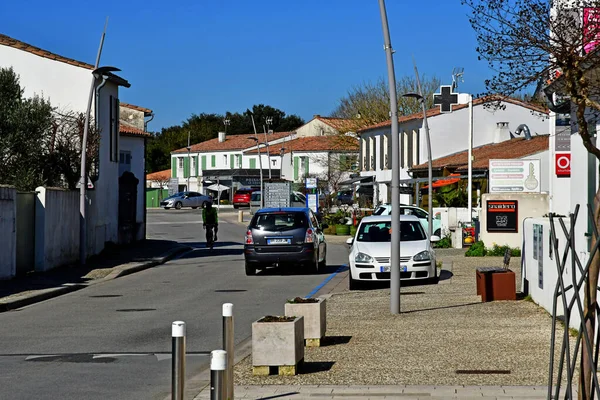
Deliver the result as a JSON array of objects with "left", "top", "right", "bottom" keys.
[{"left": 346, "top": 215, "right": 440, "bottom": 290}]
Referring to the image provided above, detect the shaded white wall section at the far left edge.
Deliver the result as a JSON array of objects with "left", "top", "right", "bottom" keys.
[{"left": 0, "top": 186, "right": 17, "bottom": 279}]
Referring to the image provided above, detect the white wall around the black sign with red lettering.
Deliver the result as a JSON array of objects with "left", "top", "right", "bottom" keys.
[{"left": 479, "top": 193, "right": 548, "bottom": 248}]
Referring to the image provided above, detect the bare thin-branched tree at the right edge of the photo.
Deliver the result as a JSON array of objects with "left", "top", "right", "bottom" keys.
[{"left": 462, "top": 0, "right": 600, "bottom": 399}]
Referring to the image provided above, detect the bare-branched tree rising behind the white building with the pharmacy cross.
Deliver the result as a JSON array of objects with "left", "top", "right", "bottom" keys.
[{"left": 332, "top": 76, "right": 441, "bottom": 126}]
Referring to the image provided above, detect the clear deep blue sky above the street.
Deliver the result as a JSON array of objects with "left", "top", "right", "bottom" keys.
[{"left": 0, "top": 0, "right": 491, "bottom": 131}]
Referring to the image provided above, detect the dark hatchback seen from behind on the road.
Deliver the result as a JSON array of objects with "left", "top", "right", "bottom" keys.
[{"left": 244, "top": 207, "right": 327, "bottom": 275}]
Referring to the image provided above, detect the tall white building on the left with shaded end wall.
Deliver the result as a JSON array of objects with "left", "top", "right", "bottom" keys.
[{"left": 0, "top": 35, "right": 150, "bottom": 255}]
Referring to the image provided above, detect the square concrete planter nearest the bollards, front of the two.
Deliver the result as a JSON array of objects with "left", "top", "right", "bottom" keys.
[{"left": 252, "top": 316, "right": 304, "bottom": 375}]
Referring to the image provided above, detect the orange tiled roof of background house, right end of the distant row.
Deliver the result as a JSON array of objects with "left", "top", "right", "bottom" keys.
[{"left": 244, "top": 135, "right": 358, "bottom": 154}]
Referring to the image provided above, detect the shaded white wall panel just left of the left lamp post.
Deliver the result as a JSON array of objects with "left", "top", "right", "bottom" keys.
[{"left": 35, "top": 187, "right": 79, "bottom": 271}]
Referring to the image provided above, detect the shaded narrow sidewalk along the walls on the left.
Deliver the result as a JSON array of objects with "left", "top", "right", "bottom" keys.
[{"left": 0, "top": 240, "right": 188, "bottom": 312}]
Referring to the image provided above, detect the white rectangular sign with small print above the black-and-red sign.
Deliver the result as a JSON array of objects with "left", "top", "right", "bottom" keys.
[{"left": 489, "top": 159, "right": 541, "bottom": 193}]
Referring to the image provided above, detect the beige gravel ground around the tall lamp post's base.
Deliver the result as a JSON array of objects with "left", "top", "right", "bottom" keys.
[{"left": 235, "top": 250, "right": 574, "bottom": 385}]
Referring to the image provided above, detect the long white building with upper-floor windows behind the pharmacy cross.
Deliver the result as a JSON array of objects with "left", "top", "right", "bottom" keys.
[{"left": 358, "top": 98, "right": 548, "bottom": 203}]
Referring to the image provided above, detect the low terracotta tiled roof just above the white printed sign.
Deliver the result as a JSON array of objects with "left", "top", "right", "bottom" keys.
[{"left": 412, "top": 135, "right": 549, "bottom": 171}]
